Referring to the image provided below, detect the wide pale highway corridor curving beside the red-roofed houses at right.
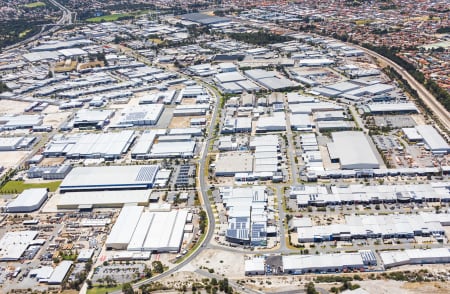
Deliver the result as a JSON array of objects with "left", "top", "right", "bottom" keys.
[{"left": 351, "top": 44, "right": 450, "bottom": 130}]
